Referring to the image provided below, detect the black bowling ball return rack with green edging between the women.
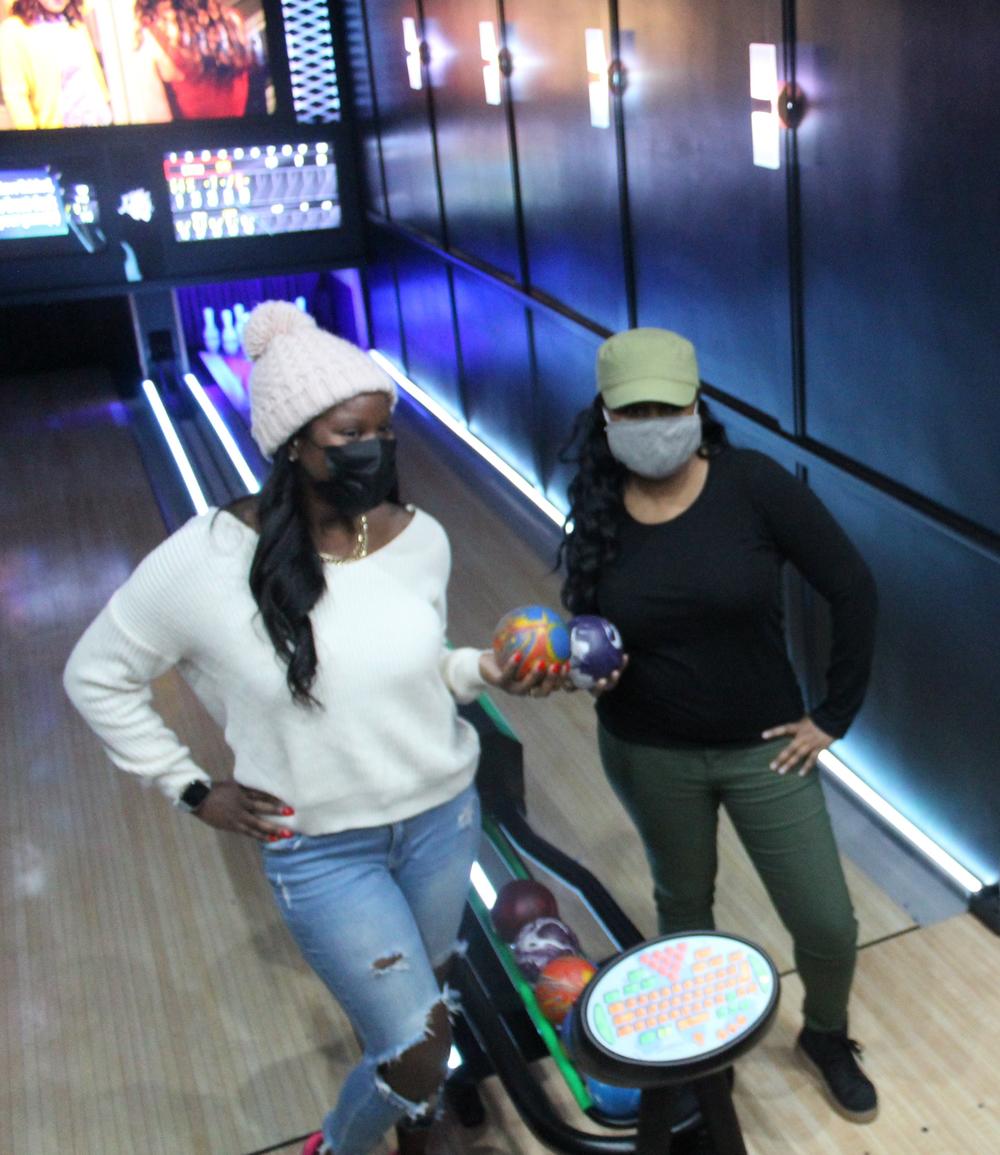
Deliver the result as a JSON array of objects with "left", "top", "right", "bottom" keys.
[{"left": 446, "top": 698, "right": 715, "bottom": 1155}]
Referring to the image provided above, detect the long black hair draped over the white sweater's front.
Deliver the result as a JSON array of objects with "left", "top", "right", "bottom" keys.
[{"left": 249, "top": 442, "right": 326, "bottom": 706}]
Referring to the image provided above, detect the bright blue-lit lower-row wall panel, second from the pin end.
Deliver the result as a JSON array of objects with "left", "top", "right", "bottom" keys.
[{"left": 396, "top": 244, "right": 465, "bottom": 418}]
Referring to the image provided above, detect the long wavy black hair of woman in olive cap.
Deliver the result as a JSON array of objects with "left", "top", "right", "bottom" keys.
[{"left": 557, "top": 395, "right": 729, "bottom": 613}]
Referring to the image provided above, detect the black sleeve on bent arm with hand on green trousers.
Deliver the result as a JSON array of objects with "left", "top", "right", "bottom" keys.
[{"left": 753, "top": 454, "right": 878, "bottom": 738}]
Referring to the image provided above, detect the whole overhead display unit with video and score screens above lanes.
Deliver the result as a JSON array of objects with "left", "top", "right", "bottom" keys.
[{"left": 0, "top": 0, "right": 363, "bottom": 312}]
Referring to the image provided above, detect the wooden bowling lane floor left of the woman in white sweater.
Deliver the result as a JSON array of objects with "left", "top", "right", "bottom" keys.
[{"left": 0, "top": 373, "right": 369, "bottom": 1155}]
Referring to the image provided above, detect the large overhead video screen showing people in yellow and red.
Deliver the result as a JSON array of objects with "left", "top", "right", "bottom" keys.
[{"left": 0, "top": 0, "right": 275, "bottom": 129}]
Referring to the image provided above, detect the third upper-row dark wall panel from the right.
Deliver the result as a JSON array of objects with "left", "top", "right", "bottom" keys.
[{"left": 505, "top": 0, "right": 628, "bottom": 329}]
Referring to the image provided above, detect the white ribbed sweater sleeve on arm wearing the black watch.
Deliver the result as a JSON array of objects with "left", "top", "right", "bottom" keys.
[{"left": 64, "top": 519, "right": 215, "bottom": 802}]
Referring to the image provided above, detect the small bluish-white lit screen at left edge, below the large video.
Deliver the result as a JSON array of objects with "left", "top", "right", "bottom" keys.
[{"left": 0, "top": 165, "right": 104, "bottom": 253}]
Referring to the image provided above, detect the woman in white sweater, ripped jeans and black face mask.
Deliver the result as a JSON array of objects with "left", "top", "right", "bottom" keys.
[{"left": 65, "top": 301, "right": 564, "bottom": 1155}]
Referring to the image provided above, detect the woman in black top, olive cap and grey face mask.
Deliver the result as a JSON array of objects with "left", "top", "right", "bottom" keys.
[{"left": 561, "top": 329, "right": 878, "bottom": 1122}]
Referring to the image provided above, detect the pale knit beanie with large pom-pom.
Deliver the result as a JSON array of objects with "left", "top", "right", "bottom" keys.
[{"left": 244, "top": 300, "right": 396, "bottom": 457}]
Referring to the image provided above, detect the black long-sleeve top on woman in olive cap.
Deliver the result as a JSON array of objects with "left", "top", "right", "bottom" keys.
[{"left": 597, "top": 448, "right": 875, "bottom": 745}]
